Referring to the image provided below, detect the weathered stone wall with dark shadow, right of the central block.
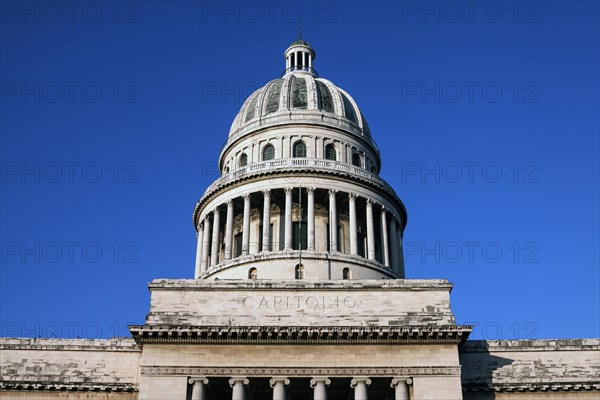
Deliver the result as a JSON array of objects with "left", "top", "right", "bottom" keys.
[{"left": 460, "top": 339, "right": 600, "bottom": 400}]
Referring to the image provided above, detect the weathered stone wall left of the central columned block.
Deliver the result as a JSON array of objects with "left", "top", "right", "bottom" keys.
[{"left": 0, "top": 338, "right": 141, "bottom": 400}]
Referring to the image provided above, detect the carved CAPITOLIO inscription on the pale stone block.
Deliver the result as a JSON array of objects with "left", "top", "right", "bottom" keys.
[{"left": 241, "top": 296, "right": 358, "bottom": 310}]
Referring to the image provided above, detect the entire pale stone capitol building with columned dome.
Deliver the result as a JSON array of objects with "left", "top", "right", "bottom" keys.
[{"left": 0, "top": 38, "right": 600, "bottom": 400}]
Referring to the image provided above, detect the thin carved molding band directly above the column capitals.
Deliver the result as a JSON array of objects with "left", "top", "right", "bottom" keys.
[{"left": 141, "top": 365, "right": 460, "bottom": 378}]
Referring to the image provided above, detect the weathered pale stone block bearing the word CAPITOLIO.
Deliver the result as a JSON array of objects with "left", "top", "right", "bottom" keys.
[{"left": 146, "top": 280, "right": 456, "bottom": 326}]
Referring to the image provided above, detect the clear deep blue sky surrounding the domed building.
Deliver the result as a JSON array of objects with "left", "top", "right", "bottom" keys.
[{"left": 0, "top": 0, "right": 600, "bottom": 339}]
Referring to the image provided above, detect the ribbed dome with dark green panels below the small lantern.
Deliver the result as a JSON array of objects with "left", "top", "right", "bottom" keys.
[{"left": 229, "top": 71, "right": 371, "bottom": 138}]
